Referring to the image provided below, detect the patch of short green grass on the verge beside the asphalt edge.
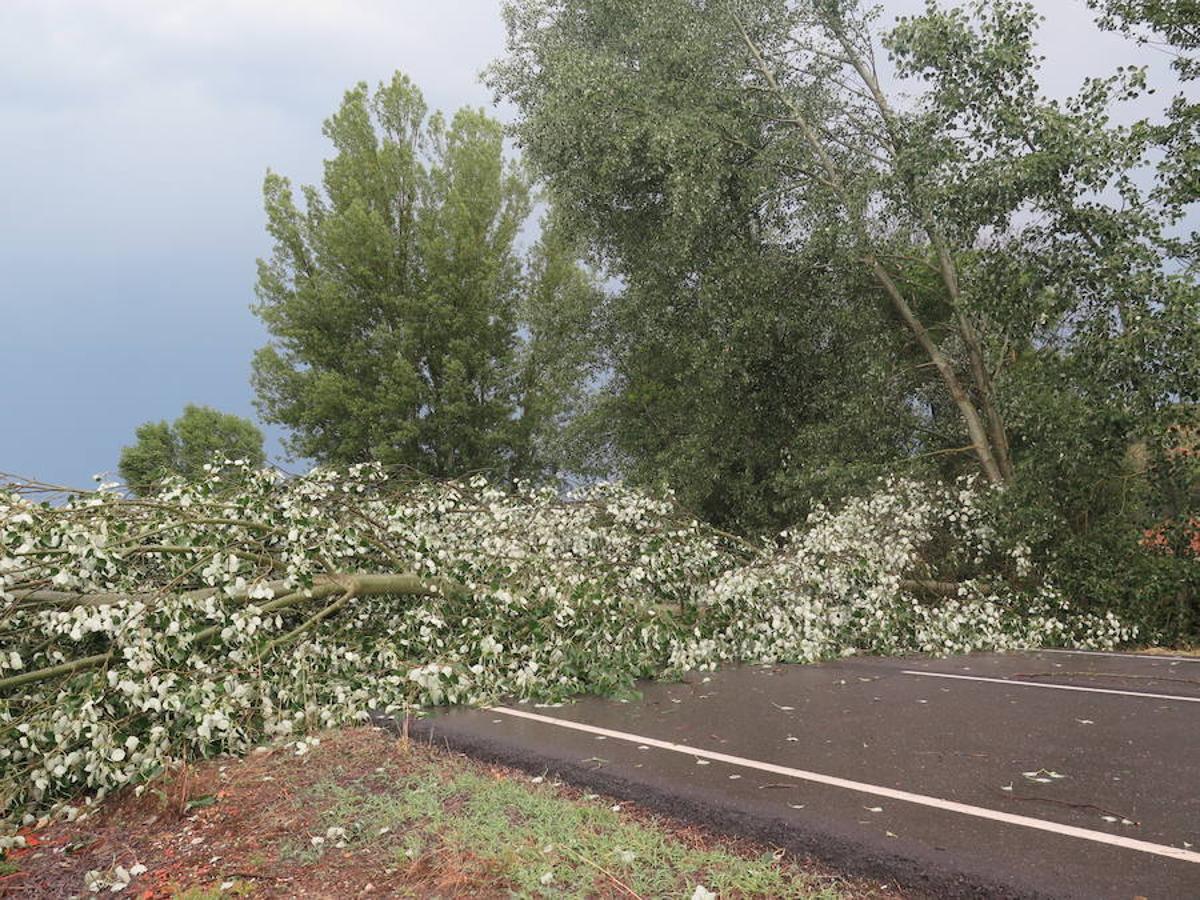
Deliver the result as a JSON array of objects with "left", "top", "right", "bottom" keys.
[{"left": 290, "top": 760, "right": 839, "bottom": 900}]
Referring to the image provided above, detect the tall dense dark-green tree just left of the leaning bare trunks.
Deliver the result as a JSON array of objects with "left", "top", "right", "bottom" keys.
[{"left": 493, "top": 4, "right": 928, "bottom": 528}]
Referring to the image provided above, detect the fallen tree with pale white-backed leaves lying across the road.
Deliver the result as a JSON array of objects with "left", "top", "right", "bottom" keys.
[{"left": 0, "top": 463, "right": 1134, "bottom": 848}]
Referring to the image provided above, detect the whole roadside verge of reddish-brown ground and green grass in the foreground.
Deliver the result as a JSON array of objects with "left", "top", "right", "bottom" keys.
[{"left": 0, "top": 728, "right": 898, "bottom": 900}]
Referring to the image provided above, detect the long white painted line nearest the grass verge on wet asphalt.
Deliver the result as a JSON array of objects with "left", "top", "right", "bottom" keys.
[{"left": 487, "top": 707, "right": 1200, "bottom": 864}]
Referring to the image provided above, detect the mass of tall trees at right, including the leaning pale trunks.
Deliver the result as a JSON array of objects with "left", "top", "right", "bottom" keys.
[{"left": 491, "top": 0, "right": 1200, "bottom": 629}]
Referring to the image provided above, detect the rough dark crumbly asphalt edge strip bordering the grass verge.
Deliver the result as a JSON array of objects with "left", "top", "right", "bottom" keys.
[{"left": 374, "top": 710, "right": 1054, "bottom": 900}]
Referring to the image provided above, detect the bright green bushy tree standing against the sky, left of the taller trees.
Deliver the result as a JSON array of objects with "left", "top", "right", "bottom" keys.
[{"left": 253, "top": 73, "right": 595, "bottom": 476}]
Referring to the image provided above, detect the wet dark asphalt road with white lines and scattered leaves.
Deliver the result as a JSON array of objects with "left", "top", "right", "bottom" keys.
[{"left": 396, "top": 652, "right": 1200, "bottom": 900}]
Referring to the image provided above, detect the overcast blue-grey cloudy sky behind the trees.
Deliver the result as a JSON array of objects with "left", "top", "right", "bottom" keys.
[{"left": 0, "top": 0, "right": 1180, "bottom": 485}]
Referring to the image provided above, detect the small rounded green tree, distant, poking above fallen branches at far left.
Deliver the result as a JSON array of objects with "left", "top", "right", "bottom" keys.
[{"left": 118, "top": 403, "right": 266, "bottom": 494}]
